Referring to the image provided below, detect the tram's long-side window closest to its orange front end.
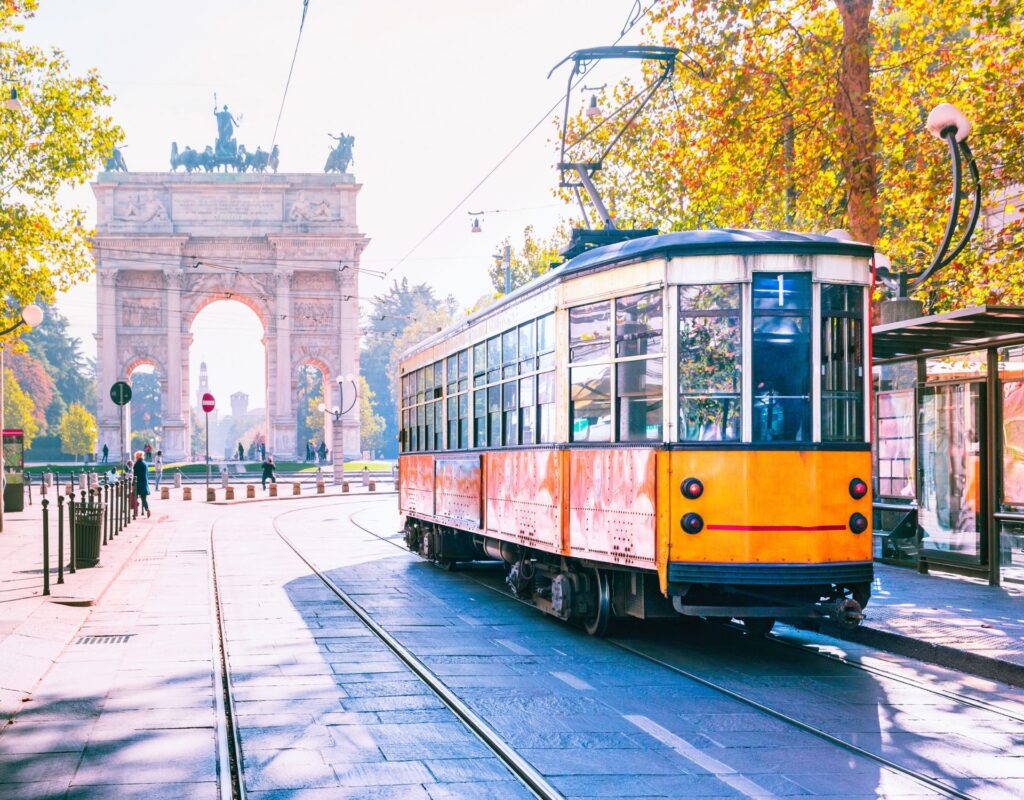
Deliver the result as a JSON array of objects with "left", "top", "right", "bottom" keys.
[{"left": 615, "top": 290, "right": 665, "bottom": 441}]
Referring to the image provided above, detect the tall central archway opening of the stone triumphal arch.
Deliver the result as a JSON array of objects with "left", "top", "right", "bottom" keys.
[{"left": 188, "top": 299, "right": 271, "bottom": 461}]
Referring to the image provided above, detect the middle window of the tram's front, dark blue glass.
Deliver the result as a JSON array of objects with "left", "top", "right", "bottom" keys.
[{"left": 752, "top": 272, "right": 811, "bottom": 441}]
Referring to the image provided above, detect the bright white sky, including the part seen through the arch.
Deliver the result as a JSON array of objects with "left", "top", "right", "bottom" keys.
[{"left": 23, "top": 0, "right": 650, "bottom": 408}]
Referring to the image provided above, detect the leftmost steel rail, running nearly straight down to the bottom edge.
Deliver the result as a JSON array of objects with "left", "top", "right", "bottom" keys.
[{"left": 210, "top": 519, "right": 246, "bottom": 800}]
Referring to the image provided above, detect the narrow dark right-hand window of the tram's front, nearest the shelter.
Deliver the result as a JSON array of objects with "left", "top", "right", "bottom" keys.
[{"left": 821, "top": 284, "right": 864, "bottom": 441}]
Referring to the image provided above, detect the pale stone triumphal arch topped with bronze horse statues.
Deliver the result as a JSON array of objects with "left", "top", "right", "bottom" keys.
[{"left": 92, "top": 127, "right": 368, "bottom": 463}]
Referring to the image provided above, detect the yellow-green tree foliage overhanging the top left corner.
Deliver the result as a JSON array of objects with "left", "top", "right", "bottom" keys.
[{"left": 0, "top": 0, "right": 122, "bottom": 328}]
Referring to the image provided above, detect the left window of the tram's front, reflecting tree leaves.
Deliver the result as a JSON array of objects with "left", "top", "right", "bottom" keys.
[{"left": 679, "top": 284, "right": 742, "bottom": 441}]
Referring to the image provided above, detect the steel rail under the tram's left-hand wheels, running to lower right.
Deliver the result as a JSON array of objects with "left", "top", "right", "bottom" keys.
[{"left": 349, "top": 511, "right": 978, "bottom": 800}]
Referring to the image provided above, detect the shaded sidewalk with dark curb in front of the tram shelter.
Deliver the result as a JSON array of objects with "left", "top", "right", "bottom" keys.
[{"left": 822, "top": 563, "right": 1024, "bottom": 686}]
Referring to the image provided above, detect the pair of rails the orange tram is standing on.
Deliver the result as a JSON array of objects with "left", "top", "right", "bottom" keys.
[{"left": 348, "top": 499, "right": 1024, "bottom": 800}]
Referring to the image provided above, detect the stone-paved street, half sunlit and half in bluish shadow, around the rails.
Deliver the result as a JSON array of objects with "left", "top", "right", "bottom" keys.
[{"left": 0, "top": 496, "right": 1024, "bottom": 800}]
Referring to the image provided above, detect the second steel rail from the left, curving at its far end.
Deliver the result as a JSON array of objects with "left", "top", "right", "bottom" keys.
[{"left": 271, "top": 501, "right": 565, "bottom": 800}]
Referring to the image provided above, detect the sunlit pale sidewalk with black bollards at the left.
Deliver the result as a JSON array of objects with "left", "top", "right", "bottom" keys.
[{"left": 0, "top": 494, "right": 163, "bottom": 725}]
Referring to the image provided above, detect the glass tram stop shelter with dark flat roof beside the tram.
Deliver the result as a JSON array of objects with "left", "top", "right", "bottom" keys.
[{"left": 872, "top": 305, "right": 1024, "bottom": 585}]
